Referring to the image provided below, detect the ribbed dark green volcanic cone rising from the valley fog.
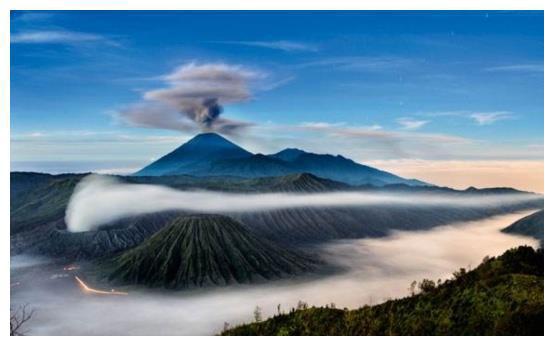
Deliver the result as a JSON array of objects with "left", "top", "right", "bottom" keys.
[{"left": 105, "top": 215, "right": 316, "bottom": 288}]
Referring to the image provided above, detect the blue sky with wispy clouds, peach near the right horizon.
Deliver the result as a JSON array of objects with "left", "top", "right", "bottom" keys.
[{"left": 11, "top": 11, "right": 544, "bottom": 192}]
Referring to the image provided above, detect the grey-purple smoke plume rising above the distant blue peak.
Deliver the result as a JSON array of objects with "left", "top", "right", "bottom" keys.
[{"left": 119, "top": 63, "right": 262, "bottom": 134}]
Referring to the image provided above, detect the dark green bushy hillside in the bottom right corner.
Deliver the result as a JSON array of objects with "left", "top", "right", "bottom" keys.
[{"left": 223, "top": 247, "right": 544, "bottom": 335}]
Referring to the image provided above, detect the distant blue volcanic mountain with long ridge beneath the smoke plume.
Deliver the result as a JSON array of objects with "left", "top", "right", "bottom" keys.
[{"left": 134, "top": 133, "right": 429, "bottom": 186}]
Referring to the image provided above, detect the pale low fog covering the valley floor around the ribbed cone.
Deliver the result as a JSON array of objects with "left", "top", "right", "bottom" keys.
[{"left": 11, "top": 212, "right": 538, "bottom": 335}]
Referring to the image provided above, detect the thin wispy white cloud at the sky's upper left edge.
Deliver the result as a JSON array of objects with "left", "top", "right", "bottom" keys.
[{"left": 10, "top": 30, "right": 118, "bottom": 46}]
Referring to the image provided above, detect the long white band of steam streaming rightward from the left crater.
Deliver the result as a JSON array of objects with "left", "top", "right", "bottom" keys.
[{"left": 65, "top": 175, "right": 537, "bottom": 232}]
